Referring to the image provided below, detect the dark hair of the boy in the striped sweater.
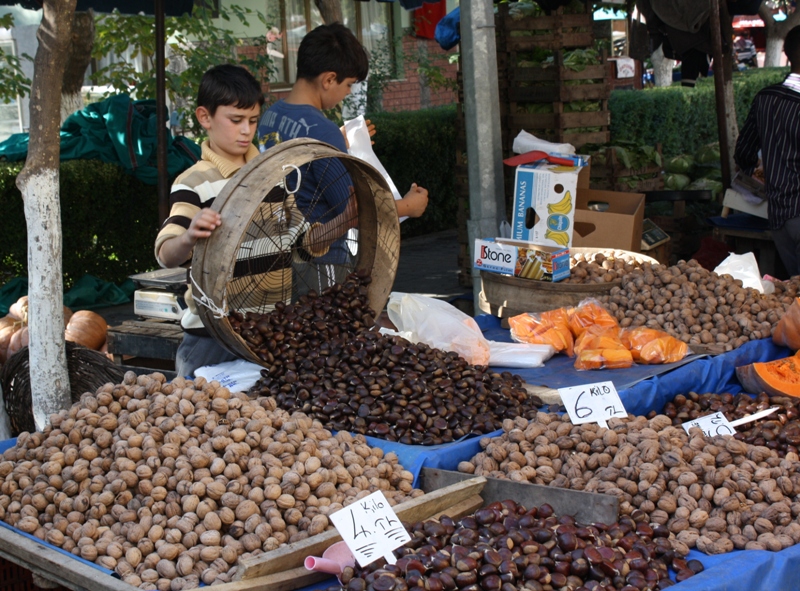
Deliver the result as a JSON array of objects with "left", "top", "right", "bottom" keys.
[{"left": 197, "top": 64, "right": 264, "bottom": 115}]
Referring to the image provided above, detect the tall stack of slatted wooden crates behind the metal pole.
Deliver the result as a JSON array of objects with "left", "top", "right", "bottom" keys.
[{"left": 456, "top": 4, "right": 611, "bottom": 285}]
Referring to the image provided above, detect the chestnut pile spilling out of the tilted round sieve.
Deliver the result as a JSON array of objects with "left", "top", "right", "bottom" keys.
[{"left": 238, "top": 274, "right": 543, "bottom": 445}]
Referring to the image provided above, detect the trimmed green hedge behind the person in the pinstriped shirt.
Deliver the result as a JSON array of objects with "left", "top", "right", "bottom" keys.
[{"left": 608, "top": 68, "right": 789, "bottom": 157}]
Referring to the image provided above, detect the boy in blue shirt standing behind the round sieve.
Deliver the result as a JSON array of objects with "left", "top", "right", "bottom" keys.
[{"left": 258, "top": 23, "right": 428, "bottom": 290}]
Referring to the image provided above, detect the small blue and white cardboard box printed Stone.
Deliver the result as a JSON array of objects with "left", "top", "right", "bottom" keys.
[{"left": 473, "top": 238, "right": 569, "bottom": 282}]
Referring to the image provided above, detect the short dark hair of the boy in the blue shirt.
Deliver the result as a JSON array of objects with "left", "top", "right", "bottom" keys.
[{"left": 297, "top": 23, "right": 369, "bottom": 82}]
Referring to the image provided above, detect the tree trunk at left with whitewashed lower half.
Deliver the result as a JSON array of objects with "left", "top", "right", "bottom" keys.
[{"left": 17, "top": 0, "right": 76, "bottom": 430}]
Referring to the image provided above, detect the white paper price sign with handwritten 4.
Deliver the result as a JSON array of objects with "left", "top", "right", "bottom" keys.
[{"left": 329, "top": 491, "right": 411, "bottom": 567}]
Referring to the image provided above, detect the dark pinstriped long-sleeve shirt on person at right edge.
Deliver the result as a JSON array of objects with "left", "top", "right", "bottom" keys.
[{"left": 734, "top": 80, "right": 800, "bottom": 230}]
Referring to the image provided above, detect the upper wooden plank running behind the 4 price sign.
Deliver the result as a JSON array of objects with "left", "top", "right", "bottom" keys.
[{"left": 228, "top": 477, "right": 486, "bottom": 591}]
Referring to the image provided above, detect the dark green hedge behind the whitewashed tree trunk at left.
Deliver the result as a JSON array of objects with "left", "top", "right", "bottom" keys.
[{"left": 0, "top": 160, "right": 158, "bottom": 289}]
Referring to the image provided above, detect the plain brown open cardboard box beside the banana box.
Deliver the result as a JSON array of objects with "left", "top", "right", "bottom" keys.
[{"left": 572, "top": 189, "right": 644, "bottom": 252}]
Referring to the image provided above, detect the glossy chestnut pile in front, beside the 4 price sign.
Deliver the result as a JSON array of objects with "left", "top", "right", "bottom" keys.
[{"left": 324, "top": 501, "right": 703, "bottom": 591}]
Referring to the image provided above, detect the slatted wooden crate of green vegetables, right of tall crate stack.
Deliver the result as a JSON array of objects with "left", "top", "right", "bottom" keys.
[{"left": 590, "top": 144, "right": 664, "bottom": 193}]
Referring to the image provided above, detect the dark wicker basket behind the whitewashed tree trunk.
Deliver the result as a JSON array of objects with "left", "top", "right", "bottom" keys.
[{"left": 0, "top": 341, "right": 125, "bottom": 434}]
